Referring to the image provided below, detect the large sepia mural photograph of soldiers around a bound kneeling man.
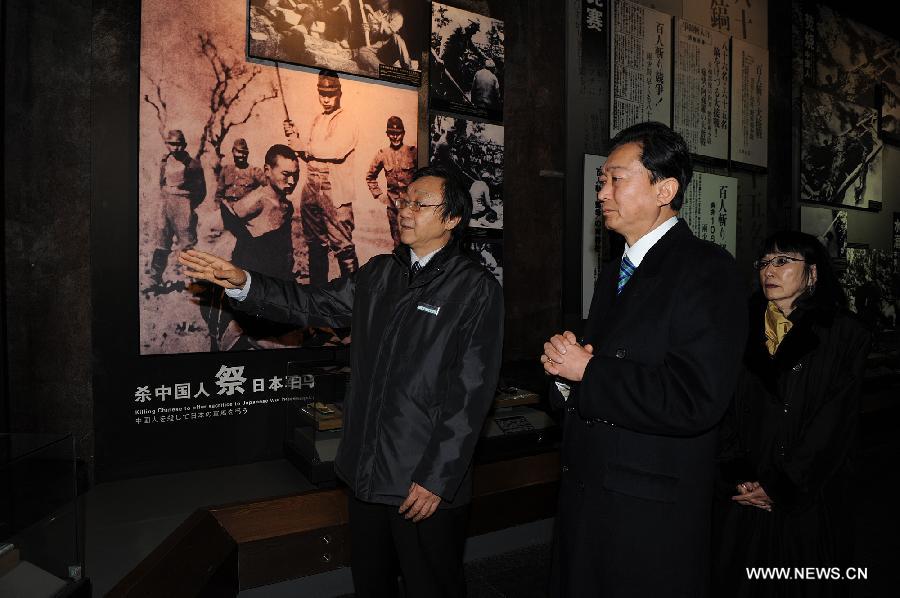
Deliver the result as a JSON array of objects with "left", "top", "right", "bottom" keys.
[{"left": 136, "top": 0, "right": 418, "bottom": 354}]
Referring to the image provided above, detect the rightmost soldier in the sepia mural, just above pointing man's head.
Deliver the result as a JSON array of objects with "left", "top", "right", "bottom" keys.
[{"left": 366, "top": 116, "right": 418, "bottom": 247}]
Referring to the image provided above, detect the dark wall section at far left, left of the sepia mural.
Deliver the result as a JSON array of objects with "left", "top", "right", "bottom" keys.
[{"left": 3, "top": 0, "right": 93, "bottom": 458}]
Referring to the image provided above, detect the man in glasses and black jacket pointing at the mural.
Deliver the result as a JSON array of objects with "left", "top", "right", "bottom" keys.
[{"left": 179, "top": 168, "right": 503, "bottom": 597}]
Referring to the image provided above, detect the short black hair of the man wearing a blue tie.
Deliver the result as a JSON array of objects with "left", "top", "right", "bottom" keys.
[{"left": 609, "top": 121, "right": 694, "bottom": 212}]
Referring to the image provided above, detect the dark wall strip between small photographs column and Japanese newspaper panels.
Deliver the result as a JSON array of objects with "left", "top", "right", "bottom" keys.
[{"left": 492, "top": 0, "right": 566, "bottom": 363}]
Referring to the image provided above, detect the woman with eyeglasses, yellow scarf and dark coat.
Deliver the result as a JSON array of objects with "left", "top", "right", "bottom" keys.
[{"left": 712, "top": 232, "right": 870, "bottom": 598}]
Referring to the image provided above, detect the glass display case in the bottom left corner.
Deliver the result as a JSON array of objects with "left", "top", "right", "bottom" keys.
[{"left": 0, "top": 434, "right": 90, "bottom": 598}]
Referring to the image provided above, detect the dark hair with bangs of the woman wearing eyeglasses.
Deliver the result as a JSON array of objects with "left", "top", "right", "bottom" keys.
[{"left": 759, "top": 230, "right": 847, "bottom": 312}]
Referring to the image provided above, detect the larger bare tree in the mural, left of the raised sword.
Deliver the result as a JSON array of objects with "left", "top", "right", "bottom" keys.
[{"left": 194, "top": 32, "right": 278, "bottom": 173}]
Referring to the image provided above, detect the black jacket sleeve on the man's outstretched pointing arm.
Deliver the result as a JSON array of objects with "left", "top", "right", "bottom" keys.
[{"left": 231, "top": 272, "right": 358, "bottom": 327}]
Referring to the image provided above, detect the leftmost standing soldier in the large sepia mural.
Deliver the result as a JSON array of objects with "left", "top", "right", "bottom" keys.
[{"left": 145, "top": 129, "right": 206, "bottom": 294}]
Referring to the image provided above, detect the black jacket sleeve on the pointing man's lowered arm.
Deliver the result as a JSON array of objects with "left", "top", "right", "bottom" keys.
[{"left": 412, "top": 279, "right": 503, "bottom": 501}]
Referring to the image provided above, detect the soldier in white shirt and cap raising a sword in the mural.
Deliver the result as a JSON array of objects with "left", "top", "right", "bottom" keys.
[{"left": 284, "top": 70, "right": 359, "bottom": 284}]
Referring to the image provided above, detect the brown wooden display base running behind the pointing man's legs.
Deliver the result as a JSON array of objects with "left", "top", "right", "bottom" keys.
[{"left": 108, "top": 451, "right": 559, "bottom": 598}]
